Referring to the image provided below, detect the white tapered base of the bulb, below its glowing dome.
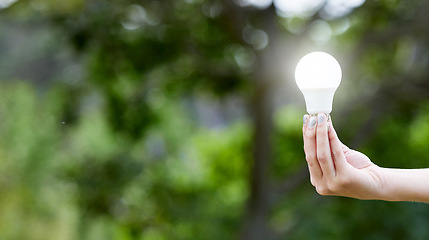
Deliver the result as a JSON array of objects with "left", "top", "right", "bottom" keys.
[{"left": 301, "top": 88, "right": 337, "bottom": 114}]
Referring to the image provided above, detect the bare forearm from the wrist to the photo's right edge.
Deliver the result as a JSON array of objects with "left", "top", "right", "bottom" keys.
[{"left": 380, "top": 168, "right": 429, "bottom": 203}]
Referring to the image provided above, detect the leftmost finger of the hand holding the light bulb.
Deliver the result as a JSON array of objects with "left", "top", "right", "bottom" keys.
[{"left": 304, "top": 116, "right": 323, "bottom": 181}]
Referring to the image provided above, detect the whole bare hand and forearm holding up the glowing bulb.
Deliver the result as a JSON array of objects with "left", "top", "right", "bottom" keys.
[{"left": 302, "top": 114, "right": 429, "bottom": 203}]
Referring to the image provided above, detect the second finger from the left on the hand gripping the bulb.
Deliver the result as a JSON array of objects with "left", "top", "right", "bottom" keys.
[{"left": 316, "top": 113, "right": 335, "bottom": 176}]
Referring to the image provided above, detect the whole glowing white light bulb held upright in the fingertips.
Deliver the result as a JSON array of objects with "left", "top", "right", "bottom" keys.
[{"left": 295, "top": 52, "right": 342, "bottom": 114}]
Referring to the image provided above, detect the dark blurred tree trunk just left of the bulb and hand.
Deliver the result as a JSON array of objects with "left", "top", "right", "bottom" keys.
[{"left": 242, "top": 6, "right": 279, "bottom": 240}]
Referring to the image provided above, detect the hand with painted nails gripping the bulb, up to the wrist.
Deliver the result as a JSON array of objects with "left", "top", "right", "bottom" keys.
[{"left": 302, "top": 114, "right": 383, "bottom": 199}]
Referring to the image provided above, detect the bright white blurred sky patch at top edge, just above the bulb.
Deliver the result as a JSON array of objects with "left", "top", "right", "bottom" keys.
[{"left": 273, "top": 0, "right": 326, "bottom": 17}]
